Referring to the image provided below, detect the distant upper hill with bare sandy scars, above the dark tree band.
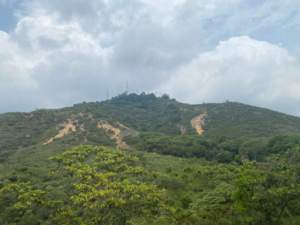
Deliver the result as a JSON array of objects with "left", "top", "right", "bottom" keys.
[{"left": 0, "top": 93, "right": 300, "bottom": 162}]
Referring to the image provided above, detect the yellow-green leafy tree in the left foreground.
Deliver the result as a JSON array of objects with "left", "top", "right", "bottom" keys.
[{"left": 1, "top": 145, "right": 164, "bottom": 225}]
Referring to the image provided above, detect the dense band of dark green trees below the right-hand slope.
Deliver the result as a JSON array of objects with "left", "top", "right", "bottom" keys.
[{"left": 124, "top": 132, "right": 300, "bottom": 164}]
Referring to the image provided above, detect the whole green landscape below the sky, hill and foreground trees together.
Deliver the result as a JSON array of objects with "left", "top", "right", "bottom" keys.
[{"left": 0, "top": 93, "right": 300, "bottom": 225}]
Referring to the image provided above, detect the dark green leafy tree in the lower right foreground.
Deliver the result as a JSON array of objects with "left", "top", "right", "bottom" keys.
[{"left": 197, "top": 148, "right": 300, "bottom": 225}]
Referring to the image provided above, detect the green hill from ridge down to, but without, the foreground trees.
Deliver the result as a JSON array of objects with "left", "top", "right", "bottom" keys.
[{"left": 0, "top": 94, "right": 300, "bottom": 225}]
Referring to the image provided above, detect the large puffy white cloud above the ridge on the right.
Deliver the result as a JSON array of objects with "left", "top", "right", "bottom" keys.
[{"left": 160, "top": 36, "right": 300, "bottom": 115}]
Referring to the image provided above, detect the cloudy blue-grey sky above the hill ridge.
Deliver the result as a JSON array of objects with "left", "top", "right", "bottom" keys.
[{"left": 0, "top": 0, "right": 300, "bottom": 116}]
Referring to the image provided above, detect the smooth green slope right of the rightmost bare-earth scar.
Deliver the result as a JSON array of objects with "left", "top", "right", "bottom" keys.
[{"left": 200, "top": 102, "right": 300, "bottom": 138}]
